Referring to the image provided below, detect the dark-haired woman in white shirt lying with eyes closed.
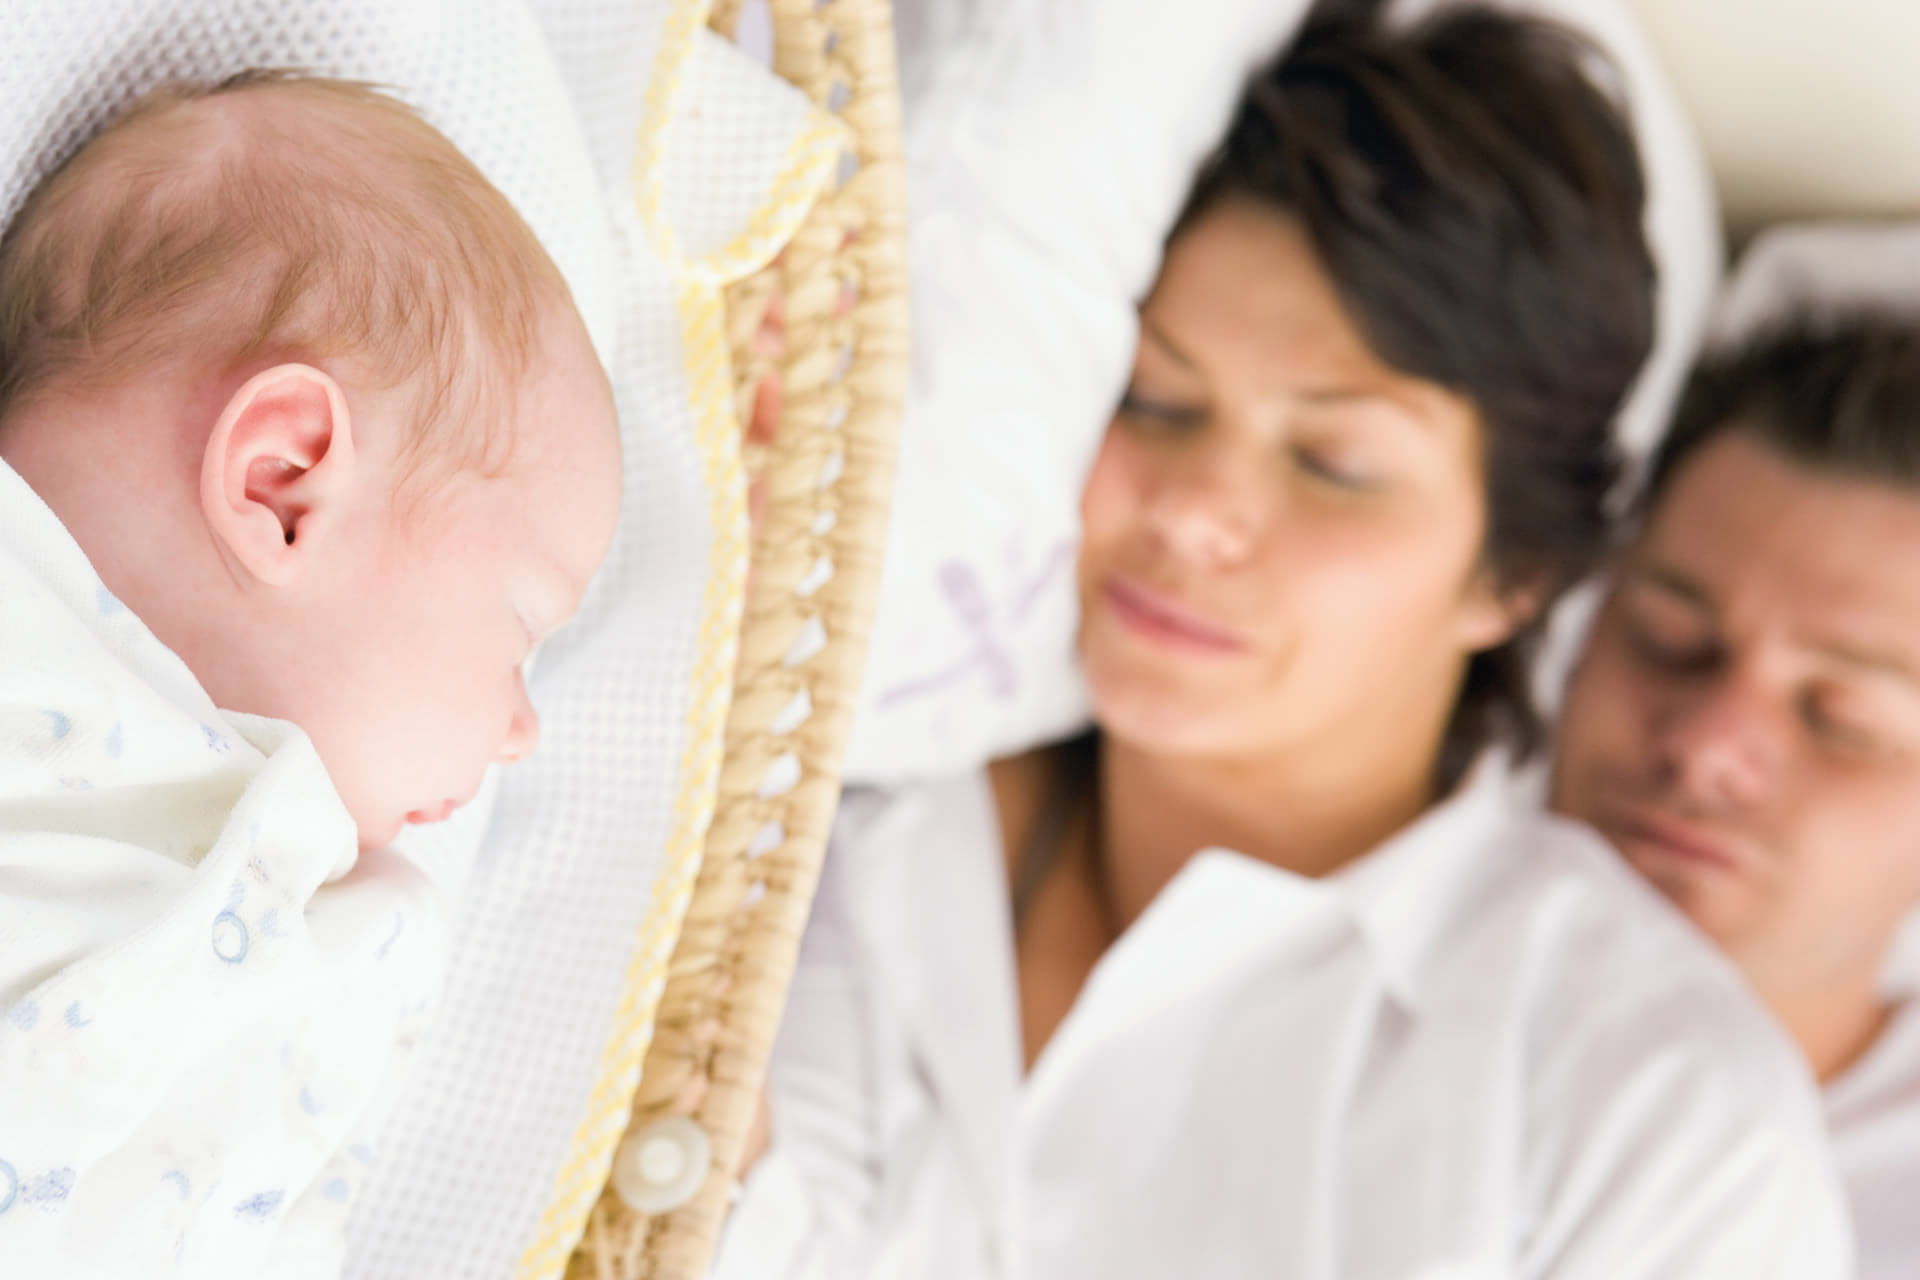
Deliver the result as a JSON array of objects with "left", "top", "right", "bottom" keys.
[{"left": 720, "top": 12, "right": 1847, "bottom": 1280}]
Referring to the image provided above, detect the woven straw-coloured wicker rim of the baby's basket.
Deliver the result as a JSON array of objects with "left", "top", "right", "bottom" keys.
[{"left": 566, "top": 0, "right": 906, "bottom": 1280}]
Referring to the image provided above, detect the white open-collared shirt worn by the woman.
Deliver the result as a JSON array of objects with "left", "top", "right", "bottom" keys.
[{"left": 716, "top": 760, "right": 1851, "bottom": 1280}]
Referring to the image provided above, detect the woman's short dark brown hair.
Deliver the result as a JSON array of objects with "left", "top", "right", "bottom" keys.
[{"left": 1173, "top": 6, "right": 1655, "bottom": 787}]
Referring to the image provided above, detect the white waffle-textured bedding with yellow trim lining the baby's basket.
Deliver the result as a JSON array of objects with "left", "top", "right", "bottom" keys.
[{"left": 0, "top": 0, "right": 839, "bottom": 1276}]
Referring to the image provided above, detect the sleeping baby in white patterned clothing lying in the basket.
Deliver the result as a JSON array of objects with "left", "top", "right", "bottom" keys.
[{"left": 0, "top": 75, "right": 620, "bottom": 1276}]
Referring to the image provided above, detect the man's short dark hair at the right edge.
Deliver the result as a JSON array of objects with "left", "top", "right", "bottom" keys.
[{"left": 1642, "top": 309, "right": 1920, "bottom": 510}]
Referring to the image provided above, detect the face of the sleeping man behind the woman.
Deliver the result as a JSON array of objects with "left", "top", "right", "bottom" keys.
[{"left": 1553, "top": 426, "right": 1920, "bottom": 990}]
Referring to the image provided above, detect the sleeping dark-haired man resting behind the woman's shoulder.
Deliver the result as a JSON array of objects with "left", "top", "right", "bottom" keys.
[{"left": 1551, "top": 313, "right": 1920, "bottom": 1280}]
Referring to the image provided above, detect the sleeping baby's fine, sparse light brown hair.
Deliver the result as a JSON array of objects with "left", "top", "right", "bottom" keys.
[{"left": 0, "top": 71, "right": 566, "bottom": 470}]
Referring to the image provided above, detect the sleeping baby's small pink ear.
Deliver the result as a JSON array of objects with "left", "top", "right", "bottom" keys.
[{"left": 200, "top": 365, "right": 357, "bottom": 587}]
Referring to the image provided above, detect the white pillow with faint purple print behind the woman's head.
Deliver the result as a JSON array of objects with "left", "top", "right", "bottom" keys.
[{"left": 847, "top": 0, "right": 1720, "bottom": 783}]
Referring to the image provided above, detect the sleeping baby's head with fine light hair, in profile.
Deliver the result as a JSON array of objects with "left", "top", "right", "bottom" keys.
[{"left": 0, "top": 75, "right": 620, "bottom": 846}]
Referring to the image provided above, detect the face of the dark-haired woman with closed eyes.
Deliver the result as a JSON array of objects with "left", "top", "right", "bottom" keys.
[{"left": 1079, "top": 201, "right": 1519, "bottom": 758}]
